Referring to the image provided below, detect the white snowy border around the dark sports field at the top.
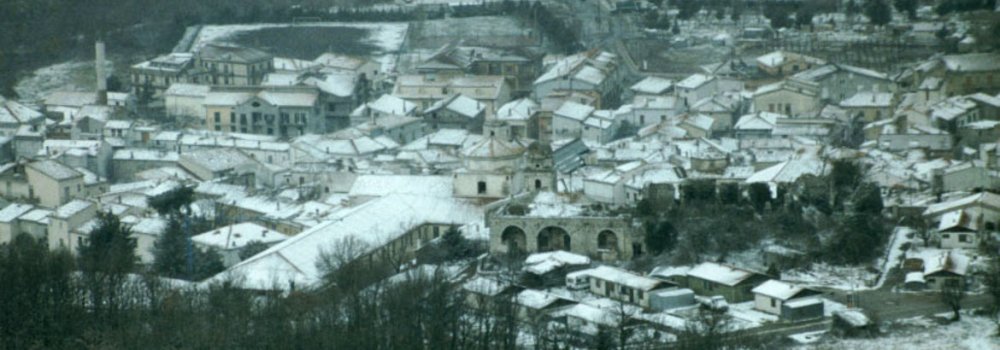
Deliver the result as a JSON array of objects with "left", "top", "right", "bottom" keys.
[{"left": 192, "top": 22, "right": 409, "bottom": 71}]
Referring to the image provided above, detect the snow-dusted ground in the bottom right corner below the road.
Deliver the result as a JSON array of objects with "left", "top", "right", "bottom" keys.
[{"left": 796, "top": 315, "right": 1000, "bottom": 350}]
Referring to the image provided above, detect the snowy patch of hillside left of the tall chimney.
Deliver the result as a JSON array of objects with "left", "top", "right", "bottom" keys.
[{"left": 14, "top": 60, "right": 114, "bottom": 102}]
